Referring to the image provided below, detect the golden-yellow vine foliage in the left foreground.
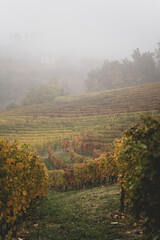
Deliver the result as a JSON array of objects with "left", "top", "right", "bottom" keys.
[{"left": 0, "top": 140, "right": 47, "bottom": 235}]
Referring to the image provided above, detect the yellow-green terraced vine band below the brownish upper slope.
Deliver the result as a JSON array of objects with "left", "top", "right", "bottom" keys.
[{"left": 0, "top": 113, "right": 148, "bottom": 151}]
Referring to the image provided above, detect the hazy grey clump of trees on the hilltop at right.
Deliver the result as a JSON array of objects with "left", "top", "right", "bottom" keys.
[{"left": 86, "top": 48, "right": 160, "bottom": 91}]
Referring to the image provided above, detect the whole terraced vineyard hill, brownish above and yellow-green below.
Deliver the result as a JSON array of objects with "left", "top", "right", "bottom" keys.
[{"left": 0, "top": 83, "right": 160, "bottom": 152}]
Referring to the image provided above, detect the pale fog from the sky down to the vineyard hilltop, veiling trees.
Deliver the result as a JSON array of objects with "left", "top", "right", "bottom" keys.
[{"left": 0, "top": 0, "right": 160, "bottom": 109}]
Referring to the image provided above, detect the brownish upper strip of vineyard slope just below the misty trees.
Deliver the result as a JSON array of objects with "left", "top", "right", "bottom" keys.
[{"left": 1, "top": 83, "right": 160, "bottom": 118}]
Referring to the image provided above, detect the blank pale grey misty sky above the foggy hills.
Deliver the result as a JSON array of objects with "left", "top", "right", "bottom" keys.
[{"left": 0, "top": 0, "right": 160, "bottom": 59}]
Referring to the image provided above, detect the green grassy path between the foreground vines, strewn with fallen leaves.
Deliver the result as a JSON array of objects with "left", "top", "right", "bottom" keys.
[{"left": 17, "top": 186, "right": 139, "bottom": 240}]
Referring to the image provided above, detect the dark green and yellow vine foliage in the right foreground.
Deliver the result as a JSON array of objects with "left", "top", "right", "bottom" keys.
[{"left": 115, "top": 117, "right": 160, "bottom": 239}]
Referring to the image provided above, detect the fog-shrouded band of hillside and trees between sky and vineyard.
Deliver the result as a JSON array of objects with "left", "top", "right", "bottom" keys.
[{"left": 0, "top": 44, "right": 160, "bottom": 109}]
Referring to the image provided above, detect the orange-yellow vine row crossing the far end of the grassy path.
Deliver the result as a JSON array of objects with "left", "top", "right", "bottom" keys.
[{"left": 50, "top": 153, "right": 117, "bottom": 189}]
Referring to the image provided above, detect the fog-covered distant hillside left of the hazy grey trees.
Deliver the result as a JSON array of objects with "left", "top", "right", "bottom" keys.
[{"left": 0, "top": 54, "right": 100, "bottom": 109}]
